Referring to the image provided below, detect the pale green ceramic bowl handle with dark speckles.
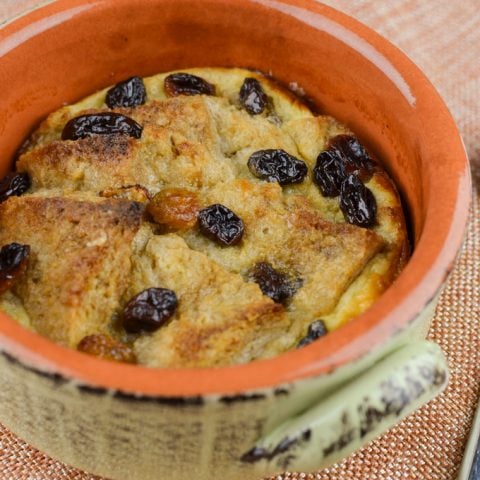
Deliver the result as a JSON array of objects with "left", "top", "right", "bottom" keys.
[{"left": 243, "top": 341, "right": 448, "bottom": 471}]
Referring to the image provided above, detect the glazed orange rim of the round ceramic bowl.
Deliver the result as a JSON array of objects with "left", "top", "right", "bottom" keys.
[{"left": 0, "top": 0, "right": 471, "bottom": 397}]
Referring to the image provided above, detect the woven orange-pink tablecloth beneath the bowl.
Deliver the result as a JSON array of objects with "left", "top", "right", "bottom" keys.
[{"left": 0, "top": 0, "right": 480, "bottom": 480}]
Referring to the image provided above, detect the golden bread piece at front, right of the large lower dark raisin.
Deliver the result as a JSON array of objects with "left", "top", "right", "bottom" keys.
[{"left": 126, "top": 234, "right": 290, "bottom": 367}]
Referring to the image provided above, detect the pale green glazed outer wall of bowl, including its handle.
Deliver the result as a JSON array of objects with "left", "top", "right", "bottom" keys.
[{"left": 0, "top": 294, "right": 448, "bottom": 480}]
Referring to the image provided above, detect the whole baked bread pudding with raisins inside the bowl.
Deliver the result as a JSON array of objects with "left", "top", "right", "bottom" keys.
[{"left": 0, "top": 68, "right": 408, "bottom": 367}]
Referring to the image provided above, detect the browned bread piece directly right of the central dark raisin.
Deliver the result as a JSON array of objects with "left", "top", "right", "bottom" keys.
[{"left": 181, "top": 179, "right": 384, "bottom": 342}]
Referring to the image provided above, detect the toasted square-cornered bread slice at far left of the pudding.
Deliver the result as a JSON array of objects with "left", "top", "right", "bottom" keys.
[{"left": 0, "top": 195, "right": 143, "bottom": 347}]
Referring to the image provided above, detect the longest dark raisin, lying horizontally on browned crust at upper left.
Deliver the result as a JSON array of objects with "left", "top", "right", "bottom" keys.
[{"left": 62, "top": 112, "right": 142, "bottom": 140}]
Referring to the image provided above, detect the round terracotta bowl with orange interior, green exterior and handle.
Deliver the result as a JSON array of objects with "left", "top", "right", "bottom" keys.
[{"left": 0, "top": 0, "right": 470, "bottom": 480}]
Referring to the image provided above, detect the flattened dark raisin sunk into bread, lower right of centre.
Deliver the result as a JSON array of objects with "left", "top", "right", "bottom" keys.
[{"left": 250, "top": 262, "right": 303, "bottom": 303}]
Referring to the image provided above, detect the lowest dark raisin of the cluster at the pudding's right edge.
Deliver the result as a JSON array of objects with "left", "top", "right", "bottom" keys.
[{"left": 340, "top": 175, "right": 377, "bottom": 227}]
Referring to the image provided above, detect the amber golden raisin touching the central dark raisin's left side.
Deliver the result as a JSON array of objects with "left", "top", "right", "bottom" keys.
[{"left": 147, "top": 188, "right": 200, "bottom": 230}]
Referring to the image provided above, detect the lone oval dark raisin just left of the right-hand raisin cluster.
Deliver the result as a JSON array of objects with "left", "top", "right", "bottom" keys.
[{"left": 247, "top": 149, "right": 308, "bottom": 185}]
